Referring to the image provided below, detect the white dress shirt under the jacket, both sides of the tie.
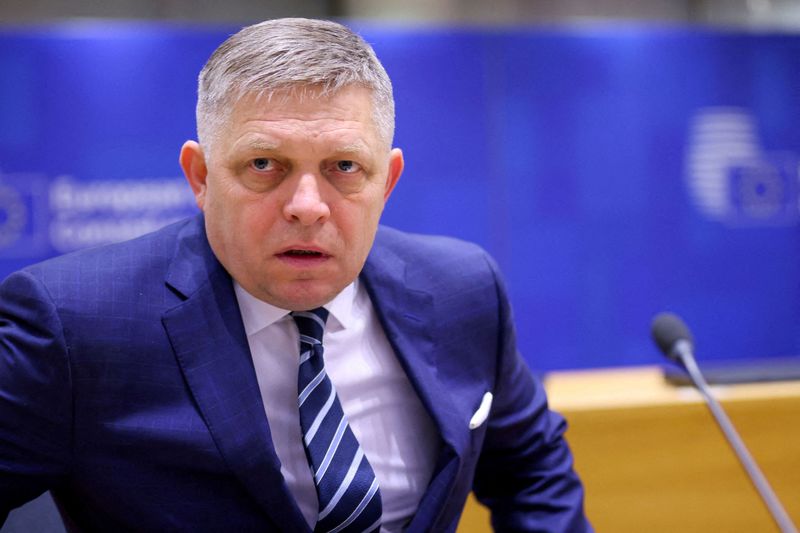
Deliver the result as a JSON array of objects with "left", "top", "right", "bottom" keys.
[{"left": 234, "top": 280, "right": 439, "bottom": 532}]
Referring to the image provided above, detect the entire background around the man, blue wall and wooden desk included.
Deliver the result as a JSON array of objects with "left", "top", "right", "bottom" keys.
[{"left": 0, "top": 0, "right": 800, "bottom": 533}]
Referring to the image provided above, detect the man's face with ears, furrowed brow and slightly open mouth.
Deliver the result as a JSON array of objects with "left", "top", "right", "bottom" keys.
[{"left": 180, "top": 86, "right": 403, "bottom": 310}]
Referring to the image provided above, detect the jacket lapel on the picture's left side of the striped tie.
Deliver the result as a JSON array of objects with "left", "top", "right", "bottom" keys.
[{"left": 162, "top": 218, "right": 308, "bottom": 531}]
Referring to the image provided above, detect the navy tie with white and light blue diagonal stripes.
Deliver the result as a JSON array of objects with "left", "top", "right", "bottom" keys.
[{"left": 292, "top": 307, "right": 382, "bottom": 533}]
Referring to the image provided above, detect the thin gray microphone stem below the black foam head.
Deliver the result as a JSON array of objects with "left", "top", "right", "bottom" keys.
[{"left": 673, "top": 340, "right": 797, "bottom": 533}]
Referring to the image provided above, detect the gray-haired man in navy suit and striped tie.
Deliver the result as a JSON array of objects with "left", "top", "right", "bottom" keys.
[{"left": 0, "top": 19, "right": 590, "bottom": 532}]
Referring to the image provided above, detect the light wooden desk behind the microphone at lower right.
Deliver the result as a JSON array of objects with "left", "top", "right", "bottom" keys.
[{"left": 459, "top": 367, "right": 800, "bottom": 533}]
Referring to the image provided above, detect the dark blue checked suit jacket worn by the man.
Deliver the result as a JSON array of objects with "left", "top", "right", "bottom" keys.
[{"left": 0, "top": 216, "right": 589, "bottom": 532}]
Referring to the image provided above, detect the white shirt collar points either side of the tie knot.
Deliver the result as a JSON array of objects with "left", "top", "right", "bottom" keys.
[{"left": 233, "top": 278, "right": 359, "bottom": 336}]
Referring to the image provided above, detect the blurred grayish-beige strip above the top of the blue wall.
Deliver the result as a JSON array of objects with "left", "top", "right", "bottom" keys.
[{"left": 0, "top": 0, "right": 800, "bottom": 25}]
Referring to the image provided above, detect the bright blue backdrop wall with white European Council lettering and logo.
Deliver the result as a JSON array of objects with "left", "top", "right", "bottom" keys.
[{"left": 0, "top": 22, "right": 800, "bottom": 370}]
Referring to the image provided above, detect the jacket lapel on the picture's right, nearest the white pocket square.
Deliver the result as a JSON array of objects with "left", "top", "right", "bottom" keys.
[{"left": 361, "top": 237, "right": 469, "bottom": 531}]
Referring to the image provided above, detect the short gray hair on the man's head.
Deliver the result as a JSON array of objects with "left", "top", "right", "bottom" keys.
[{"left": 197, "top": 18, "right": 394, "bottom": 151}]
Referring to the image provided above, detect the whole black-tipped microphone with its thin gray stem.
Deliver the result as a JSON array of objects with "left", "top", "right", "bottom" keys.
[{"left": 651, "top": 313, "right": 797, "bottom": 533}]
